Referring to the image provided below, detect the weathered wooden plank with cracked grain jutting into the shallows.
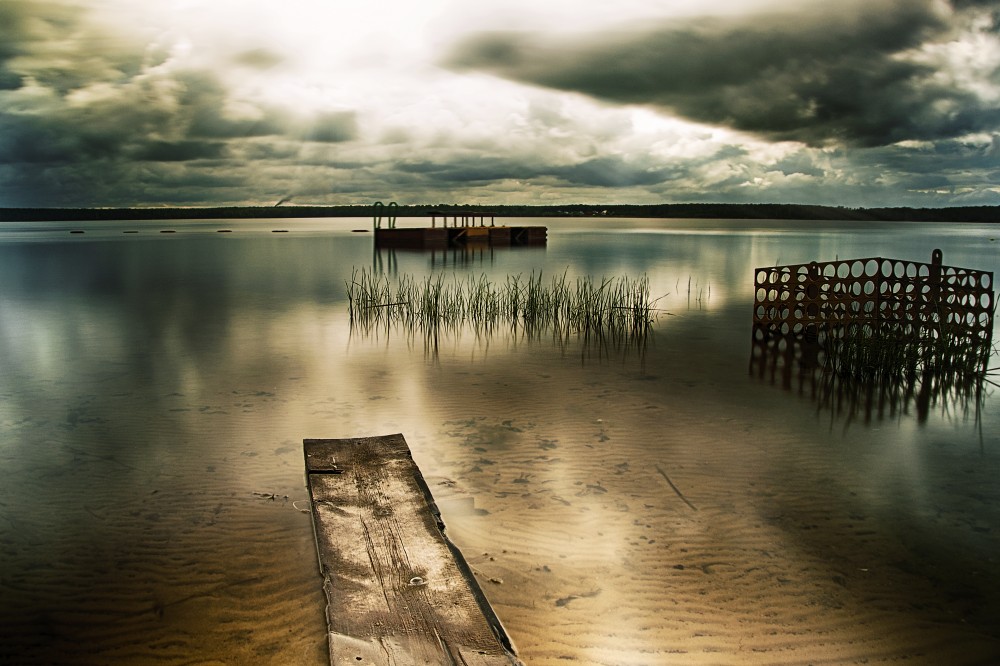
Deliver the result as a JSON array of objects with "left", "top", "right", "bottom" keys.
[{"left": 304, "top": 434, "right": 521, "bottom": 666}]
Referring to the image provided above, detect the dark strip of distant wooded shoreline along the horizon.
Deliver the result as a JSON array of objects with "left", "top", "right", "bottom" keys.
[{"left": 0, "top": 203, "right": 1000, "bottom": 223}]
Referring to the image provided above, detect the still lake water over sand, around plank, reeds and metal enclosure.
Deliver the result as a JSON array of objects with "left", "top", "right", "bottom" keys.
[{"left": 0, "top": 219, "right": 1000, "bottom": 666}]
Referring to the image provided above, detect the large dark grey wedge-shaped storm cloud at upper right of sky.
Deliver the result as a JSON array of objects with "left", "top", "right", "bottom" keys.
[{"left": 447, "top": 0, "right": 1000, "bottom": 146}]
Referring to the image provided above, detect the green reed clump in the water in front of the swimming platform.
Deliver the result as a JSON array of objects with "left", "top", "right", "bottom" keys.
[{"left": 347, "top": 269, "right": 657, "bottom": 336}]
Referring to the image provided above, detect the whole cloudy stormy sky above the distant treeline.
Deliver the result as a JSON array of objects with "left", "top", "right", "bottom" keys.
[{"left": 0, "top": 0, "right": 1000, "bottom": 206}]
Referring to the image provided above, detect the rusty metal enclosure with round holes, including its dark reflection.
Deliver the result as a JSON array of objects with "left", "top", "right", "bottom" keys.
[{"left": 750, "top": 250, "right": 996, "bottom": 424}]
